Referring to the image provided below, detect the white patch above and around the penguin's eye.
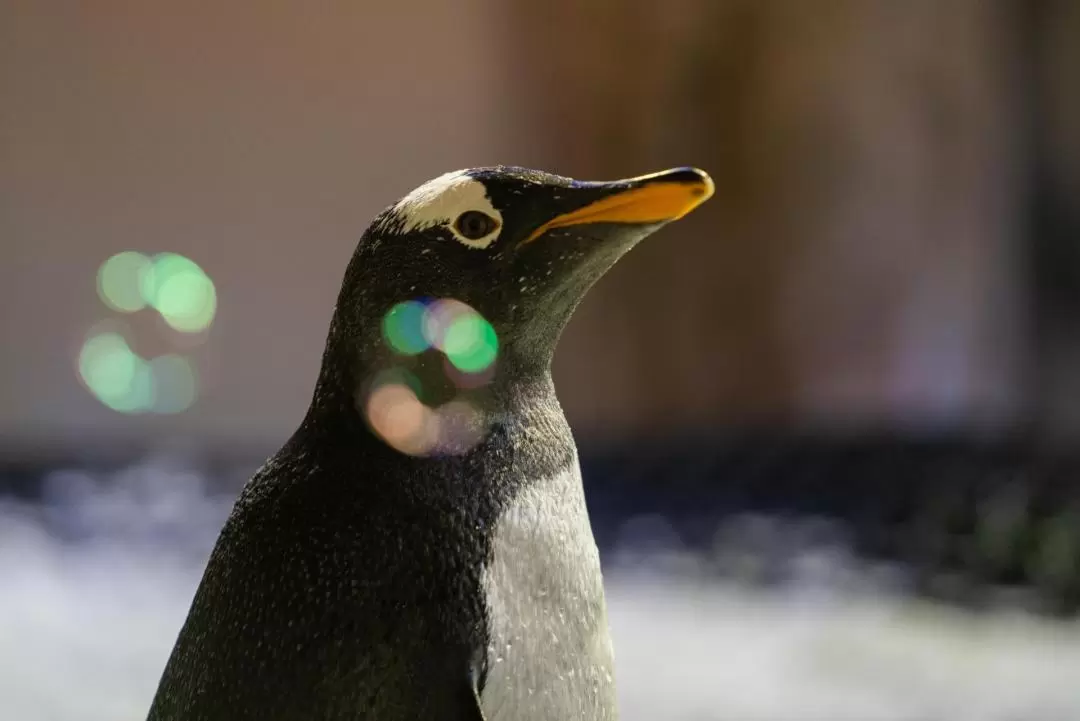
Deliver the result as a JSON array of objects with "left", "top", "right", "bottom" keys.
[{"left": 393, "top": 171, "right": 502, "bottom": 249}]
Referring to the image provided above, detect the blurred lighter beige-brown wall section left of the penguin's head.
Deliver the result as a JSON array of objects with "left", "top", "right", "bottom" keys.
[{"left": 0, "top": 0, "right": 514, "bottom": 451}]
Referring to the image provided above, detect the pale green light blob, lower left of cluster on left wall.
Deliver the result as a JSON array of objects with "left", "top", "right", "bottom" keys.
[{"left": 79, "top": 332, "right": 153, "bottom": 413}]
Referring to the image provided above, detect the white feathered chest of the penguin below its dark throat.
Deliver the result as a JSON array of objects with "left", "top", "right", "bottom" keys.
[{"left": 481, "top": 464, "right": 616, "bottom": 721}]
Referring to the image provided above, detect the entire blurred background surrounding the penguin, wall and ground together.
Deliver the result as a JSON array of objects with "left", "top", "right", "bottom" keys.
[{"left": 0, "top": 0, "right": 1080, "bottom": 721}]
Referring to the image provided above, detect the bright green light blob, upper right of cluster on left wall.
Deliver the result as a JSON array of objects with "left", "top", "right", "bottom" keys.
[{"left": 139, "top": 253, "right": 217, "bottom": 332}]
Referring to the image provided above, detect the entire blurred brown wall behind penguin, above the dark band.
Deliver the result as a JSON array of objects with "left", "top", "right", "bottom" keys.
[{"left": 0, "top": 0, "right": 1080, "bottom": 451}]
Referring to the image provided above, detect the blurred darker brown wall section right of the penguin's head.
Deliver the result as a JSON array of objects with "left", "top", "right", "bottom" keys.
[{"left": 505, "top": 0, "right": 1026, "bottom": 436}]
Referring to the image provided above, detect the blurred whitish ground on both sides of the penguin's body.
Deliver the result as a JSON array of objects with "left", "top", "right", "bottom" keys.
[{"left": 0, "top": 465, "right": 1080, "bottom": 721}]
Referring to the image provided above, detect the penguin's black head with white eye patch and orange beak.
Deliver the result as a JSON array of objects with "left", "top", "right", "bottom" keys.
[{"left": 335, "top": 166, "right": 713, "bottom": 377}]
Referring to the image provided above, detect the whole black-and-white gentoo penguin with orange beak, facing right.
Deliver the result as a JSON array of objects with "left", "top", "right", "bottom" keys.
[{"left": 149, "top": 166, "right": 713, "bottom": 721}]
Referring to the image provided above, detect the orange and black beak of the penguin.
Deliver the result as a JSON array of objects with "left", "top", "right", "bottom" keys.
[{"left": 523, "top": 167, "right": 714, "bottom": 245}]
